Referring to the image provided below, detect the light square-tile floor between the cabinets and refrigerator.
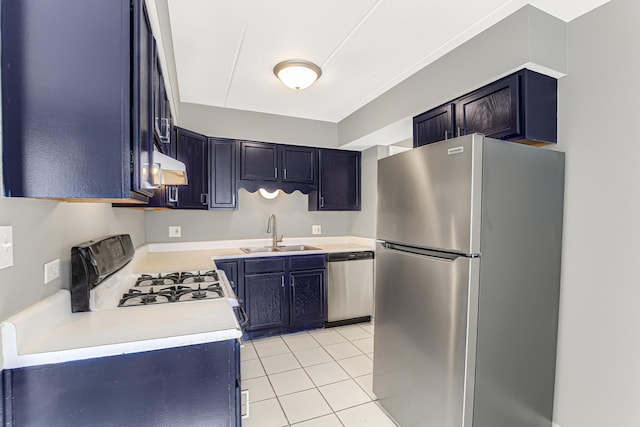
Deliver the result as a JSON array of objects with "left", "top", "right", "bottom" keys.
[{"left": 240, "top": 323, "right": 396, "bottom": 427}]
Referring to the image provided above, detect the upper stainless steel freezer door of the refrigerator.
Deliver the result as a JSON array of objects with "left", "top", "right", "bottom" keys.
[{"left": 377, "top": 134, "right": 484, "bottom": 254}]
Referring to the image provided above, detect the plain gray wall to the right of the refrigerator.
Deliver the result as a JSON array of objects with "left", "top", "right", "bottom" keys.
[{"left": 555, "top": 0, "right": 640, "bottom": 427}]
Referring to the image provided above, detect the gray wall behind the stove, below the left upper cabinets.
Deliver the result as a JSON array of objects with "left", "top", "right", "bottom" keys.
[{"left": 0, "top": 198, "right": 145, "bottom": 321}]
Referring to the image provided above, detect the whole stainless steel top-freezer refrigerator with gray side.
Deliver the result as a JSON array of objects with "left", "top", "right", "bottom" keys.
[{"left": 373, "top": 134, "right": 564, "bottom": 427}]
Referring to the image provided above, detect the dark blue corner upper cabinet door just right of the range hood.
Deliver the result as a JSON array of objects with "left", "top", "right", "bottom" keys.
[{"left": 177, "top": 129, "right": 209, "bottom": 209}]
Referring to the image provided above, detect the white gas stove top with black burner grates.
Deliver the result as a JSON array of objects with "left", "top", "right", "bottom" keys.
[{"left": 118, "top": 270, "right": 231, "bottom": 307}]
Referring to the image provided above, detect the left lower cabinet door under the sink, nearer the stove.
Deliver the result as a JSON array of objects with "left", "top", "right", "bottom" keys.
[{"left": 244, "top": 273, "right": 288, "bottom": 331}]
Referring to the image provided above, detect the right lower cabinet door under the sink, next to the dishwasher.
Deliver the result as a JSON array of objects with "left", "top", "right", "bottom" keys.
[{"left": 289, "top": 270, "right": 326, "bottom": 325}]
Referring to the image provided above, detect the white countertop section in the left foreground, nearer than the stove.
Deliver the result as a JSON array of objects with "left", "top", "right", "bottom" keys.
[{"left": 0, "top": 289, "right": 242, "bottom": 369}]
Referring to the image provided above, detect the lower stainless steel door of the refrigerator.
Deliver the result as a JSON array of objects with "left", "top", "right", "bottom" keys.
[{"left": 373, "top": 244, "right": 480, "bottom": 427}]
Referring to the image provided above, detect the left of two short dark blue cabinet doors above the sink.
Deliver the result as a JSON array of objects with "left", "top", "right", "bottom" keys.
[{"left": 240, "top": 141, "right": 278, "bottom": 181}]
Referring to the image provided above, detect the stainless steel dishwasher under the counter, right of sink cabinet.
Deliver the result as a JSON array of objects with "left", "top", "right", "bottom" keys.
[{"left": 325, "top": 251, "right": 373, "bottom": 327}]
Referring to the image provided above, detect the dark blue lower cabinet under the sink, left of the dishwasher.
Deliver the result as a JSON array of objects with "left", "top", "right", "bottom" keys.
[{"left": 244, "top": 254, "right": 327, "bottom": 338}]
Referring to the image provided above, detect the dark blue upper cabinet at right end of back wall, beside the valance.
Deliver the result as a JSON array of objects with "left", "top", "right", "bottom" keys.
[{"left": 309, "top": 149, "right": 361, "bottom": 211}]
